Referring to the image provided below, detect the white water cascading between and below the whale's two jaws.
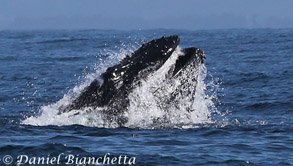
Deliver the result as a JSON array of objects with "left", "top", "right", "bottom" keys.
[{"left": 126, "top": 48, "right": 213, "bottom": 128}]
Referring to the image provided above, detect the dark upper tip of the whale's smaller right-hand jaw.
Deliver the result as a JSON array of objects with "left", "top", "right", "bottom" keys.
[{"left": 172, "top": 47, "right": 206, "bottom": 76}]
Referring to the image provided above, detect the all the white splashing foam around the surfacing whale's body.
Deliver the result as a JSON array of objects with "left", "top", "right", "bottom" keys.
[{"left": 22, "top": 48, "right": 217, "bottom": 128}]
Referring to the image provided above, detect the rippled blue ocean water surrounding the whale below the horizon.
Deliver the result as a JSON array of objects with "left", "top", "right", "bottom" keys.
[{"left": 0, "top": 29, "right": 293, "bottom": 166}]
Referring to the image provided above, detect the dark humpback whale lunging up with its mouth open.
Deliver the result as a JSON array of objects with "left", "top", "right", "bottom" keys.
[{"left": 59, "top": 36, "right": 205, "bottom": 126}]
